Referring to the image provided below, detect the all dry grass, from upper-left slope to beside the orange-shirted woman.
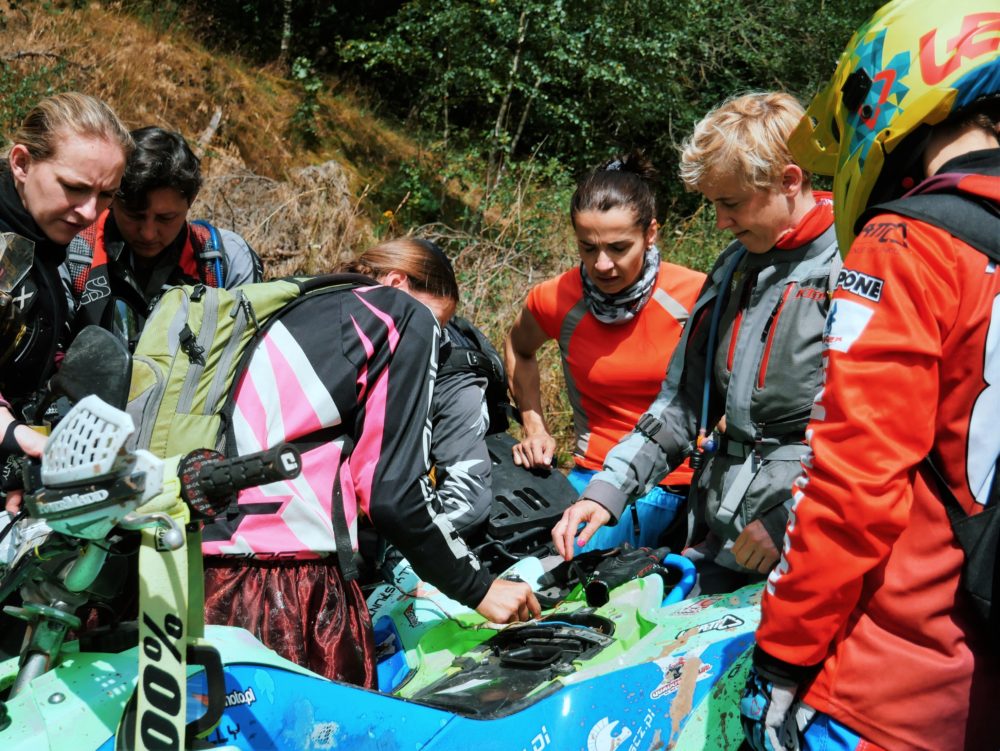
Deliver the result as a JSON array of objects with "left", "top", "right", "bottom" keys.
[{"left": 0, "top": 0, "right": 680, "bottom": 462}]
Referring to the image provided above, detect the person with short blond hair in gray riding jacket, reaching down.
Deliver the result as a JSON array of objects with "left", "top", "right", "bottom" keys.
[{"left": 553, "top": 93, "right": 840, "bottom": 592}]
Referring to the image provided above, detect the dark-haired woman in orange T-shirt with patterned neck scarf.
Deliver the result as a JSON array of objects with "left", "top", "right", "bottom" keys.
[{"left": 505, "top": 153, "right": 705, "bottom": 549}]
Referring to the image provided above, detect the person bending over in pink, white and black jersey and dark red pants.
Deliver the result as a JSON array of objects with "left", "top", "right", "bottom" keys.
[{"left": 197, "top": 272, "right": 539, "bottom": 687}]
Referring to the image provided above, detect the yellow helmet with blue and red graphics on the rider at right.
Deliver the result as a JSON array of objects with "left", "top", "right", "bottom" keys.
[{"left": 789, "top": 0, "right": 1000, "bottom": 252}]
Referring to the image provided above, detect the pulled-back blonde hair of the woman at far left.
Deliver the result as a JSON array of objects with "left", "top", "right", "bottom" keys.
[{"left": 11, "top": 91, "right": 135, "bottom": 162}]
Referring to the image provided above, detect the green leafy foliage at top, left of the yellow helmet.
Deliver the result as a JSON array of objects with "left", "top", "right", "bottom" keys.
[{"left": 340, "top": 0, "right": 880, "bottom": 205}]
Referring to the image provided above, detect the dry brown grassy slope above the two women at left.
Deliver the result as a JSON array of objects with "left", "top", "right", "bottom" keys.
[{"left": 0, "top": 2, "right": 426, "bottom": 277}]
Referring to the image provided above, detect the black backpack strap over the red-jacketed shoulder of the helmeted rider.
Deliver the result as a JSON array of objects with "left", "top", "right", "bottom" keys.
[{"left": 865, "top": 192, "right": 1000, "bottom": 263}]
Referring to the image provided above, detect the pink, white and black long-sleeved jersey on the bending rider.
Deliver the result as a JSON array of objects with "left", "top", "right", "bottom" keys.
[{"left": 203, "top": 286, "right": 490, "bottom": 605}]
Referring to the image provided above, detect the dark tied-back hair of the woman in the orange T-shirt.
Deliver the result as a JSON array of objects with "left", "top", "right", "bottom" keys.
[{"left": 569, "top": 151, "right": 656, "bottom": 230}]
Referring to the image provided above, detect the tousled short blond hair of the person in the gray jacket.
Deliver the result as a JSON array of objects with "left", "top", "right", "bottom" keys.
[{"left": 680, "top": 92, "right": 810, "bottom": 191}]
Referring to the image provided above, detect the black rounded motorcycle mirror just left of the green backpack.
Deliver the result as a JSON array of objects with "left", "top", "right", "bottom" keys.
[{"left": 49, "top": 326, "right": 132, "bottom": 409}]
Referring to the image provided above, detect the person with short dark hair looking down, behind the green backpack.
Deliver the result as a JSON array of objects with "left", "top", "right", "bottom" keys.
[{"left": 60, "top": 126, "right": 262, "bottom": 344}]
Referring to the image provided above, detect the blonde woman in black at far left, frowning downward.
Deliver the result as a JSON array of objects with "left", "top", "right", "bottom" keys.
[{"left": 0, "top": 92, "right": 132, "bottom": 494}]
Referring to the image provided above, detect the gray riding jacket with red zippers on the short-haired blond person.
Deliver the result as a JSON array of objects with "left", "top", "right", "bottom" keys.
[{"left": 583, "top": 226, "right": 840, "bottom": 569}]
